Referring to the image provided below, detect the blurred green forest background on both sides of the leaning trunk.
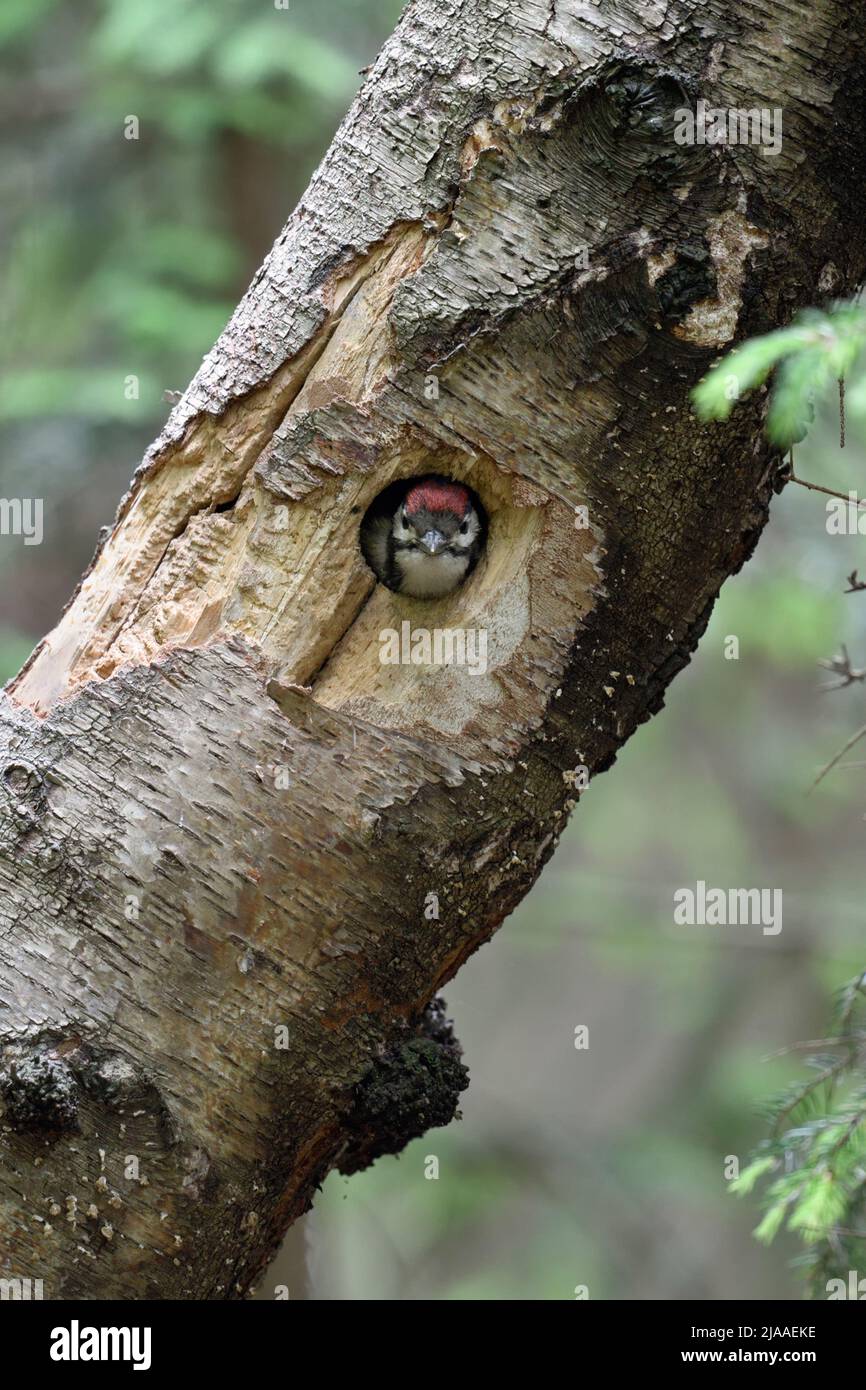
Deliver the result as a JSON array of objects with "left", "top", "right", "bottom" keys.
[{"left": 0, "top": 0, "right": 866, "bottom": 1300}]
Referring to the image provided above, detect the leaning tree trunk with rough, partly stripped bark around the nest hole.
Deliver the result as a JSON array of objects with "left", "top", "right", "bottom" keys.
[{"left": 0, "top": 0, "right": 866, "bottom": 1298}]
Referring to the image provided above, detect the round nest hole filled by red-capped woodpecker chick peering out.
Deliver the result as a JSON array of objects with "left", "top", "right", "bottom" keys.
[{"left": 361, "top": 474, "right": 484, "bottom": 599}]
